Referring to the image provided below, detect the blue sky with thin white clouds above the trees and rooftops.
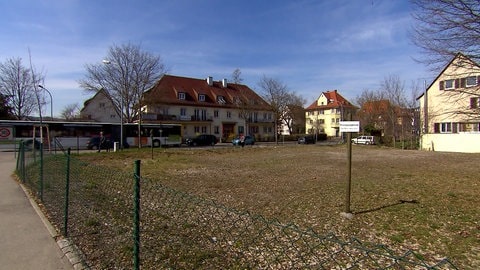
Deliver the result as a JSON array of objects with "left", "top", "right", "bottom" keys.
[{"left": 0, "top": 0, "right": 433, "bottom": 115}]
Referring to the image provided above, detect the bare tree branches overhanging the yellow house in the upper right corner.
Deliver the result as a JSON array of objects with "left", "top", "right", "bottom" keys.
[{"left": 410, "top": 0, "right": 480, "bottom": 69}]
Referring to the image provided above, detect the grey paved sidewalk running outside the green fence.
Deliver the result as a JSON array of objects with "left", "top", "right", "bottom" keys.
[{"left": 0, "top": 151, "right": 73, "bottom": 270}]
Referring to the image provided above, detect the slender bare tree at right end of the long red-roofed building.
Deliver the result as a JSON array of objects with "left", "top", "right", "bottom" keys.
[{"left": 258, "top": 75, "right": 291, "bottom": 143}]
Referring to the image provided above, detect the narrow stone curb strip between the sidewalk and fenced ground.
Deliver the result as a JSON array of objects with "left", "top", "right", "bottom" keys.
[{"left": 18, "top": 182, "right": 90, "bottom": 270}]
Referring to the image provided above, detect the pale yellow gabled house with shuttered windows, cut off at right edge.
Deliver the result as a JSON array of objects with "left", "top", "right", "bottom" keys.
[{"left": 418, "top": 53, "right": 480, "bottom": 153}]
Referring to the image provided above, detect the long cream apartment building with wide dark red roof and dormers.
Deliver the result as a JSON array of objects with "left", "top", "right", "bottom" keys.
[{"left": 142, "top": 75, "right": 275, "bottom": 142}]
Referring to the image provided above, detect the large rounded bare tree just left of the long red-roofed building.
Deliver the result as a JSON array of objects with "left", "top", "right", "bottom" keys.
[{"left": 79, "top": 44, "right": 167, "bottom": 122}]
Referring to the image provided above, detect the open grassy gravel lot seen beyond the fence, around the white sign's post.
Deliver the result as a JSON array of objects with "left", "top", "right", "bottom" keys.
[{"left": 81, "top": 145, "right": 480, "bottom": 269}]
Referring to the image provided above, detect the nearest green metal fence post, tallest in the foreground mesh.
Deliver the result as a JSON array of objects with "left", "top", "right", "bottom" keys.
[{"left": 133, "top": 160, "right": 140, "bottom": 270}]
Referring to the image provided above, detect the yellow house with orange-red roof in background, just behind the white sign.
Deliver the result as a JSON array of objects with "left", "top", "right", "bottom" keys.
[{"left": 305, "top": 90, "right": 355, "bottom": 137}]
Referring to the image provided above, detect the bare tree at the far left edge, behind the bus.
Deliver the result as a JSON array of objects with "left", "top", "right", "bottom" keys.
[{"left": 0, "top": 58, "right": 45, "bottom": 119}]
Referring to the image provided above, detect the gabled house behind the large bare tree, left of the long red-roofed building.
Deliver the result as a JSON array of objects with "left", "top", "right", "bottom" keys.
[{"left": 80, "top": 89, "right": 121, "bottom": 123}]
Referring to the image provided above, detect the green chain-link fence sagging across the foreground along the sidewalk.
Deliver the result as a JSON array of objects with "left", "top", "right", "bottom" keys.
[{"left": 17, "top": 142, "right": 457, "bottom": 269}]
